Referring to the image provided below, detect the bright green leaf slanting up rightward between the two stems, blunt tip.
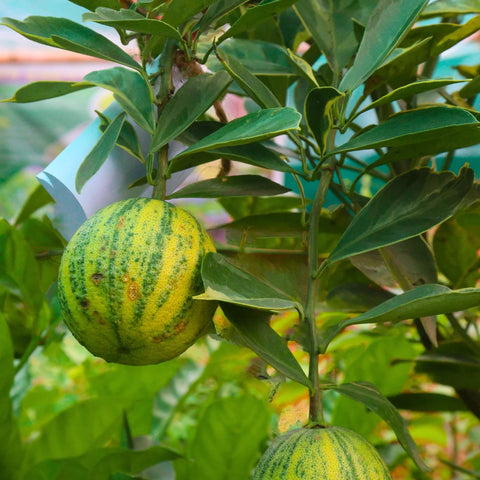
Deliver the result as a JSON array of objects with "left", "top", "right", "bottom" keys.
[{"left": 173, "top": 107, "right": 301, "bottom": 161}]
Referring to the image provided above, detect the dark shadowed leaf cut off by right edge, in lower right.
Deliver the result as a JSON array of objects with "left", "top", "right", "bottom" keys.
[{"left": 415, "top": 342, "right": 480, "bottom": 389}]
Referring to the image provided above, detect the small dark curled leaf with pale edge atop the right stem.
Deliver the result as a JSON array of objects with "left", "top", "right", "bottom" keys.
[{"left": 305, "top": 87, "right": 344, "bottom": 153}]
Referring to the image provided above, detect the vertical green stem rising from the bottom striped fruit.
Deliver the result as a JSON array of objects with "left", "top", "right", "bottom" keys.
[{"left": 304, "top": 158, "right": 335, "bottom": 424}]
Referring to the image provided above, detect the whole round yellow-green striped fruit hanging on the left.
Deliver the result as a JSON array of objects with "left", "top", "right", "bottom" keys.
[{"left": 58, "top": 198, "right": 215, "bottom": 365}]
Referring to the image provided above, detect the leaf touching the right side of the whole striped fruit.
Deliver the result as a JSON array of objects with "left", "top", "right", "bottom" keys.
[{"left": 195, "top": 253, "right": 299, "bottom": 311}]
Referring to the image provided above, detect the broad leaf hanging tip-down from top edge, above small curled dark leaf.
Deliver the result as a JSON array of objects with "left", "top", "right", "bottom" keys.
[{"left": 293, "top": 0, "right": 376, "bottom": 74}]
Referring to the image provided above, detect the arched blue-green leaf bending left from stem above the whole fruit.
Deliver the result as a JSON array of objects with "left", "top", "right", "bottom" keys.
[{"left": 82, "top": 67, "right": 155, "bottom": 133}]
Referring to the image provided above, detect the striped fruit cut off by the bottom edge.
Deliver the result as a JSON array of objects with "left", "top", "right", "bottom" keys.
[{"left": 253, "top": 427, "right": 392, "bottom": 480}]
